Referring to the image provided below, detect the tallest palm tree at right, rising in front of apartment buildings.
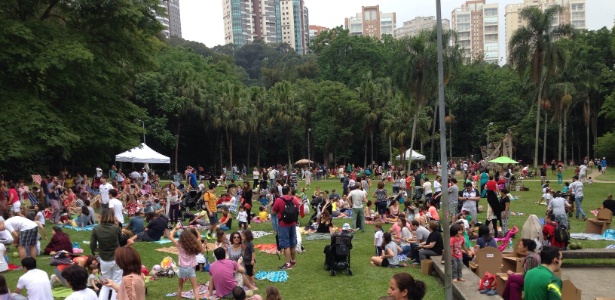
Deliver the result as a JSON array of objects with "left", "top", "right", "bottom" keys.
[{"left": 508, "top": 5, "right": 573, "bottom": 166}]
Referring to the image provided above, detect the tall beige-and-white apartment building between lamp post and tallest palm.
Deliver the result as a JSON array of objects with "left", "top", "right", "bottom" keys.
[{"left": 451, "top": 0, "right": 500, "bottom": 63}]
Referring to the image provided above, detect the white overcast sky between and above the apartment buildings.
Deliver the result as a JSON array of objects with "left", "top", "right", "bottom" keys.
[{"left": 180, "top": 0, "right": 615, "bottom": 61}]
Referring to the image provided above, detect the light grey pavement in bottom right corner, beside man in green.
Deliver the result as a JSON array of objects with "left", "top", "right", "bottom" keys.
[{"left": 562, "top": 268, "right": 615, "bottom": 299}]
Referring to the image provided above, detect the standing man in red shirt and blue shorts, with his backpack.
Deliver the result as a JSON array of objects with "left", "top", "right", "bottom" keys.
[{"left": 271, "top": 186, "right": 300, "bottom": 270}]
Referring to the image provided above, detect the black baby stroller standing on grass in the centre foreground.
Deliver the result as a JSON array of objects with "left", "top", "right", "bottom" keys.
[{"left": 323, "top": 233, "right": 352, "bottom": 276}]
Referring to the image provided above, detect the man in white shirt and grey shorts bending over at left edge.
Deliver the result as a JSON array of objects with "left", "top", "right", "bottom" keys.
[{"left": 0, "top": 216, "right": 38, "bottom": 259}]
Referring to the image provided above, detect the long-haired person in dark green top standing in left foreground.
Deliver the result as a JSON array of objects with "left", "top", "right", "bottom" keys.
[{"left": 90, "top": 208, "right": 122, "bottom": 300}]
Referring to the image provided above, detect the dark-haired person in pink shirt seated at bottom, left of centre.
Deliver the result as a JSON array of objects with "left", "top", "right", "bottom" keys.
[{"left": 209, "top": 247, "right": 245, "bottom": 299}]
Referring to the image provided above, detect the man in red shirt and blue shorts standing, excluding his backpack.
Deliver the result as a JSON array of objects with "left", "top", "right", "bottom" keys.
[{"left": 271, "top": 186, "right": 300, "bottom": 270}]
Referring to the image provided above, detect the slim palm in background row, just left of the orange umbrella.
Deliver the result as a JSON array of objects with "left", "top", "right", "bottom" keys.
[{"left": 269, "top": 81, "right": 304, "bottom": 166}]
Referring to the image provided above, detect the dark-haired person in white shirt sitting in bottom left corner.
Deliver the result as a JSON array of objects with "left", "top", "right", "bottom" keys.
[{"left": 11, "top": 257, "right": 53, "bottom": 300}]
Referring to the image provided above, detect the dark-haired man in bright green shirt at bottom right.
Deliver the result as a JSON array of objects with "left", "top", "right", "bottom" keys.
[{"left": 523, "top": 246, "right": 562, "bottom": 300}]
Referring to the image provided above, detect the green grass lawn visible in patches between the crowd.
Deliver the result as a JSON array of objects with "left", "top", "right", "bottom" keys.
[{"left": 4, "top": 168, "right": 615, "bottom": 299}]
